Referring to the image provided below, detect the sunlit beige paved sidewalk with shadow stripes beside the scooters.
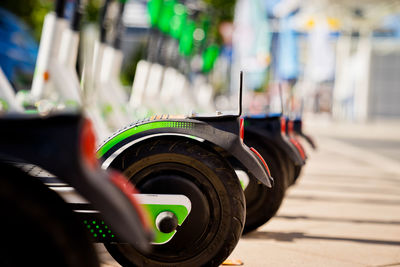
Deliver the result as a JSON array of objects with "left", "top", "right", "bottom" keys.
[{"left": 97, "top": 120, "right": 400, "bottom": 267}]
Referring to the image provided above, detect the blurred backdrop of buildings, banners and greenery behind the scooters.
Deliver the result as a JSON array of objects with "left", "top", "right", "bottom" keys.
[{"left": 0, "top": 0, "right": 400, "bottom": 122}]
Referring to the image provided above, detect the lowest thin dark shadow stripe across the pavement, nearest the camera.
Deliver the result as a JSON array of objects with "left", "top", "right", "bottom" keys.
[{"left": 242, "top": 231, "right": 400, "bottom": 246}]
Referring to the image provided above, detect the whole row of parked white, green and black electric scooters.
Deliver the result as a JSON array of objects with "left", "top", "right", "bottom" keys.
[{"left": 0, "top": 0, "right": 314, "bottom": 266}]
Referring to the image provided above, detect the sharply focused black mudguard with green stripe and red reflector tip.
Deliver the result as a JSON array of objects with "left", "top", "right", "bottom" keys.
[{"left": 97, "top": 115, "right": 273, "bottom": 187}]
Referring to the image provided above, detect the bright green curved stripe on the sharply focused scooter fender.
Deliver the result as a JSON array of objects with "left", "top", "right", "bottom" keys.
[{"left": 97, "top": 121, "right": 194, "bottom": 158}]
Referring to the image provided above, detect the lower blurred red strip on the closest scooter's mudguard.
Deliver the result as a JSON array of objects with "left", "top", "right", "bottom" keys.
[{"left": 110, "top": 171, "right": 150, "bottom": 231}]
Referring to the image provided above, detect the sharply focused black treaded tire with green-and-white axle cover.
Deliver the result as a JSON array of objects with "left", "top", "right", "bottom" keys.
[{"left": 106, "top": 137, "right": 245, "bottom": 266}]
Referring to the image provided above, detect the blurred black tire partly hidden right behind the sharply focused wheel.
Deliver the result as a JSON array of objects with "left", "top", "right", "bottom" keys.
[{"left": 243, "top": 139, "right": 289, "bottom": 234}]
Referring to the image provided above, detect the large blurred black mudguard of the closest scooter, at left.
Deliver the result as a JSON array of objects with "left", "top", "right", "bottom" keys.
[{"left": 0, "top": 114, "right": 149, "bottom": 251}]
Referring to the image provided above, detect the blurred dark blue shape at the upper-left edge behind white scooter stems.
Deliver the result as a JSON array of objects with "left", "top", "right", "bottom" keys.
[{"left": 0, "top": 8, "right": 38, "bottom": 88}]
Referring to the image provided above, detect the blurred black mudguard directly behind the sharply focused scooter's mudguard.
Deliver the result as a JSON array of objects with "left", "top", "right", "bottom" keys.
[{"left": 244, "top": 115, "right": 305, "bottom": 166}]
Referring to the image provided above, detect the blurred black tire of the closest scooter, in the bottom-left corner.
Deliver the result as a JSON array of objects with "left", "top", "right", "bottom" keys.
[{"left": 0, "top": 163, "right": 99, "bottom": 267}]
